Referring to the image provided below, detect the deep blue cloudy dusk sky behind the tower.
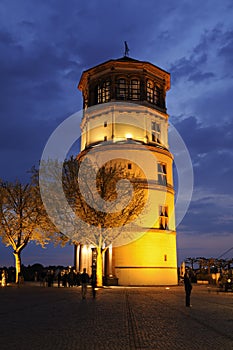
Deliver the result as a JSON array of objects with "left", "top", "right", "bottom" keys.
[{"left": 0, "top": 0, "right": 233, "bottom": 266}]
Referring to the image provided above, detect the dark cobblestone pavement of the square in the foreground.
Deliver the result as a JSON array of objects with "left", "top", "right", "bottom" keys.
[{"left": 0, "top": 285, "right": 233, "bottom": 350}]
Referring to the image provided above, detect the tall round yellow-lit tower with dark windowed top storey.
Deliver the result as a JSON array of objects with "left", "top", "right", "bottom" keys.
[{"left": 76, "top": 56, "right": 177, "bottom": 285}]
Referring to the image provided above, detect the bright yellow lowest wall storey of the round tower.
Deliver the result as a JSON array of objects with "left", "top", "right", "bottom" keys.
[{"left": 112, "top": 230, "right": 177, "bottom": 285}]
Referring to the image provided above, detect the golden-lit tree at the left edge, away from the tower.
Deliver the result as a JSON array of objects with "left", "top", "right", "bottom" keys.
[{"left": 0, "top": 181, "right": 61, "bottom": 283}]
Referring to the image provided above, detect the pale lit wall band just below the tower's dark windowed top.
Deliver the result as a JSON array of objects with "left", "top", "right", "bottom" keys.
[{"left": 81, "top": 102, "right": 169, "bottom": 150}]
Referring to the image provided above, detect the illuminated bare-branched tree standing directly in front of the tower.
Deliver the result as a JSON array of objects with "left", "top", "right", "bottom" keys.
[{"left": 40, "top": 158, "right": 147, "bottom": 286}]
